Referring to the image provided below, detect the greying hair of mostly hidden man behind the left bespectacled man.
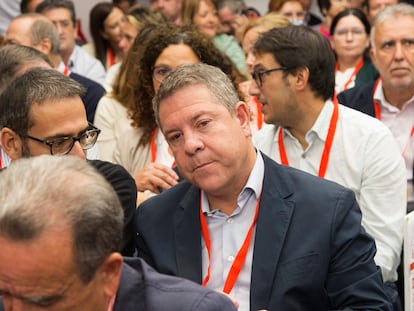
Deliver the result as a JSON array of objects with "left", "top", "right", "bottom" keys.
[{"left": 0, "top": 44, "right": 53, "bottom": 94}]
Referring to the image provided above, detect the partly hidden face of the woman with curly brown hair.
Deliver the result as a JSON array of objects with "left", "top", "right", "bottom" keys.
[{"left": 152, "top": 43, "right": 200, "bottom": 92}]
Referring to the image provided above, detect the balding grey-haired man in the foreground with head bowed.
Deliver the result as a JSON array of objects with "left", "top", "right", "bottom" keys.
[{"left": 0, "top": 155, "right": 236, "bottom": 311}]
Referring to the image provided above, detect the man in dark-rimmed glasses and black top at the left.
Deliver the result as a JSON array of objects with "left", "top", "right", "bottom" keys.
[{"left": 0, "top": 67, "right": 137, "bottom": 256}]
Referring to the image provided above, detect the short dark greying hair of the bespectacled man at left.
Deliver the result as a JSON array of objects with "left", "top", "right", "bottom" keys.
[{"left": 0, "top": 68, "right": 86, "bottom": 134}]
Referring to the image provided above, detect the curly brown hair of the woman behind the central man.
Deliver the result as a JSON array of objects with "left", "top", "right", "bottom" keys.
[{"left": 114, "top": 24, "right": 244, "bottom": 145}]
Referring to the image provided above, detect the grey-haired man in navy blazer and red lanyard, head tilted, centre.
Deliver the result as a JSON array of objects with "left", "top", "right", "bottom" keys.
[{"left": 136, "top": 64, "right": 390, "bottom": 311}]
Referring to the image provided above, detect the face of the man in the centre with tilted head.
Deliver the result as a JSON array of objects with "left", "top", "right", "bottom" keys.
[{"left": 159, "top": 85, "right": 255, "bottom": 195}]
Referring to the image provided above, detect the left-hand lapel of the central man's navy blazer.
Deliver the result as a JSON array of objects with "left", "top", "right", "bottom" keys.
[{"left": 174, "top": 187, "right": 202, "bottom": 284}]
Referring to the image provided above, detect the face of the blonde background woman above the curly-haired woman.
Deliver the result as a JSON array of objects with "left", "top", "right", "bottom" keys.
[{"left": 193, "top": 0, "right": 219, "bottom": 37}]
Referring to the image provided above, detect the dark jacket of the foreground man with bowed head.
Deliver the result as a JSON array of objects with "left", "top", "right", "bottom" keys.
[{"left": 114, "top": 258, "right": 237, "bottom": 311}]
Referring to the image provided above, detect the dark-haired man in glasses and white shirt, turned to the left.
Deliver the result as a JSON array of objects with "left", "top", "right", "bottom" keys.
[{"left": 250, "top": 26, "right": 406, "bottom": 310}]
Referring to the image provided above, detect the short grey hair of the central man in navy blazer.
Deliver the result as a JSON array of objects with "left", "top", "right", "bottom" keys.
[{"left": 152, "top": 63, "right": 240, "bottom": 128}]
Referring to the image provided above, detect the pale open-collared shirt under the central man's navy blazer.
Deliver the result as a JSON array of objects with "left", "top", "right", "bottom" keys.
[{"left": 201, "top": 152, "right": 264, "bottom": 311}]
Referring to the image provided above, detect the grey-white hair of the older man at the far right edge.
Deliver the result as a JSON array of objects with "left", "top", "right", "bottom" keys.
[{"left": 370, "top": 3, "right": 414, "bottom": 51}]
